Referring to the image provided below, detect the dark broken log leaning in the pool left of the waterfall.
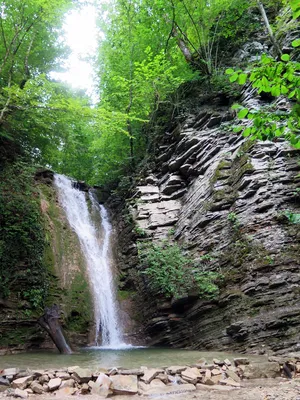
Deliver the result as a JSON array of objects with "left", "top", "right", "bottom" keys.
[{"left": 38, "top": 304, "right": 72, "bottom": 354}]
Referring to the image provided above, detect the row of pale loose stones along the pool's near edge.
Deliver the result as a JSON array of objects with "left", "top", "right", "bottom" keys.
[{"left": 0, "top": 357, "right": 300, "bottom": 398}]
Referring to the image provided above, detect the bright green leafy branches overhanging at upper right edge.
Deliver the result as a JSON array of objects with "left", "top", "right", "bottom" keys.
[{"left": 226, "top": 39, "right": 300, "bottom": 148}]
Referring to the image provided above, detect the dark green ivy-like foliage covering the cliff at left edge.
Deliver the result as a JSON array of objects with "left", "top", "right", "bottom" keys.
[{"left": 0, "top": 161, "right": 48, "bottom": 309}]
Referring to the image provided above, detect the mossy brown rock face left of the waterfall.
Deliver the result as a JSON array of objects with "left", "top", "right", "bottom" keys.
[{"left": 0, "top": 170, "right": 93, "bottom": 354}]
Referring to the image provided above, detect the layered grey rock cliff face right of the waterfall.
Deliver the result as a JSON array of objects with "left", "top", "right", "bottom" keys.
[{"left": 112, "top": 81, "right": 300, "bottom": 353}]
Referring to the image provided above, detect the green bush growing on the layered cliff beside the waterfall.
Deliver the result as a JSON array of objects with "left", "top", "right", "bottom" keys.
[{"left": 139, "top": 242, "right": 220, "bottom": 298}]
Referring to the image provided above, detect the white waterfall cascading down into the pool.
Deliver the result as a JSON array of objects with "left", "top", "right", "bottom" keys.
[{"left": 55, "top": 175, "right": 126, "bottom": 348}]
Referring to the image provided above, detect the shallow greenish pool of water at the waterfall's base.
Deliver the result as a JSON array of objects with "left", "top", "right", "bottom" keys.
[{"left": 0, "top": 348, "right": 265, "bottom": 370}]
